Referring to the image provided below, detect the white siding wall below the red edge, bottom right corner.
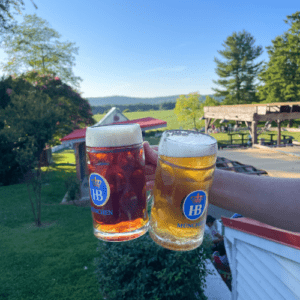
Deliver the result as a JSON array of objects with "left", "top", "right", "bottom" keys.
[{"left": 225, "top": 227, "right": 300, "bottom": 300}]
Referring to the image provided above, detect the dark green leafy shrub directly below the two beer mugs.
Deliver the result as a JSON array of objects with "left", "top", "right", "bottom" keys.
[{"left": 95, "top": 234, "right": 211, "bottom": 300}]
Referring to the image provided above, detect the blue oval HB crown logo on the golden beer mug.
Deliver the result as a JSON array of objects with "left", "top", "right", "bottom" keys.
[{"left": 182, "top": 191, "right": 207, "bottom": 221}]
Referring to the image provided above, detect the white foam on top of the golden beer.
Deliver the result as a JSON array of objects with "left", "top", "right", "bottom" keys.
[{"left": 158, "top": 130, "right": 218, "bottom": 157}]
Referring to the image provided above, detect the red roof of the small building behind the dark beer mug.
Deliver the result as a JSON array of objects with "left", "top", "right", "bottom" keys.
[{"left": 60, "top": 117, "right": 167, "bottom": 142}]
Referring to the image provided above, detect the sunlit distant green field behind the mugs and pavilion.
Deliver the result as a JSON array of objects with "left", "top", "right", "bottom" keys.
[{"left": 94, "top": 110, "right": 300, "bottom": 145}]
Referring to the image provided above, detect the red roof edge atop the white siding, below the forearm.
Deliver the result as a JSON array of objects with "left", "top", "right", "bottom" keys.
[{"left": 222, "top": 217, "right": 300, "bottom": 250}]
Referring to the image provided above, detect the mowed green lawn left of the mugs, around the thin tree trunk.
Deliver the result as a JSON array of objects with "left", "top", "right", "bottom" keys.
[{"left": 0, "top": 150, "right": 102, "bottom": 300}]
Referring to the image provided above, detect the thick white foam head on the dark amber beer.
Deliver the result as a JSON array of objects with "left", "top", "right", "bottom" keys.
[{"left": 85, "top": 124, "right": 143, "bottom": 147}]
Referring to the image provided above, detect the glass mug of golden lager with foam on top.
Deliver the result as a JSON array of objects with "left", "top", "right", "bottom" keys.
[{"left": 149, "top": 130, "right": 217, "bottom": 251}]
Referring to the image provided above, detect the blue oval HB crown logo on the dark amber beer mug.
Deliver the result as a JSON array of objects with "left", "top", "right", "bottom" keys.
[{"left": 89, "top": 173, "right": 110, "bottom": 206}]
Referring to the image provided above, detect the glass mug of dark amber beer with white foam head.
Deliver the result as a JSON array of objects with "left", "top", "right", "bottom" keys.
[{"left": 86, "top": 124, "right": 148, "bottom": 241}]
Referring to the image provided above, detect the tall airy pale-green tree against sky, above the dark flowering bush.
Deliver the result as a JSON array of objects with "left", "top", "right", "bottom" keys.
[{"left": 2, "top": 14, "right": 82, "bottom": 87}]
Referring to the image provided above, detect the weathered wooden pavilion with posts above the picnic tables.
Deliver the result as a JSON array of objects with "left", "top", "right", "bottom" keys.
[{"left": 203, "top": 102, "right": 300, "bottom": 145}]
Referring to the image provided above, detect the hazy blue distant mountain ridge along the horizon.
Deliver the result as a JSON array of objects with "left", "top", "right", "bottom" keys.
[{"left": 86, "top": 95, "right": 223, "bottom": 107}]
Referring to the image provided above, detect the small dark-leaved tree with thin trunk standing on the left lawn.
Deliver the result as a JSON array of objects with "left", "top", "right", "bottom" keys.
[{"left": 0, "top": 89, "right": 65, "bottom": 226}]
